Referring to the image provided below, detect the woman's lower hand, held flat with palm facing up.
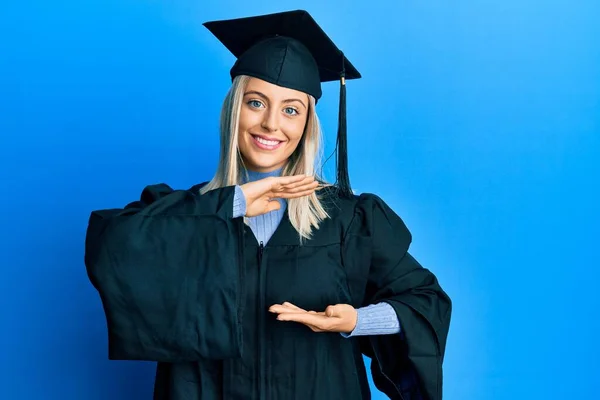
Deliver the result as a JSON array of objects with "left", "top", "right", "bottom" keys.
[{"left": 269, "top": 302, "right": 358, "bottom": 333}]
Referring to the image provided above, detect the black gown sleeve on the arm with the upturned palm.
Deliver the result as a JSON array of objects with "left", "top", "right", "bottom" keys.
[{"left": 347, "top": 194, "right": 452, "bottom": 400}]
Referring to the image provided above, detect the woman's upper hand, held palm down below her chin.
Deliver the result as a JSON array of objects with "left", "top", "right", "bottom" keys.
[{"left": 240, "top": 175, "right": 319, "bottom": 217}]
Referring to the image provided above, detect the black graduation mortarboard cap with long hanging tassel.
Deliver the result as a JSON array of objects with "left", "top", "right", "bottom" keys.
[{"left": 204, "top": 10, "right": 361, "bottom": 196}]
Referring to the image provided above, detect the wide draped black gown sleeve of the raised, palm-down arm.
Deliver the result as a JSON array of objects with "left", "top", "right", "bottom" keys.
[{"left": 85, "top": 184, "right": 244, "bottom": 362}]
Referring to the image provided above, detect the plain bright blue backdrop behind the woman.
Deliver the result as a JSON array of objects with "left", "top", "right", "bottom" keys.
[{"left": 0, "top": 0, "right": 600, "bottom": 400}]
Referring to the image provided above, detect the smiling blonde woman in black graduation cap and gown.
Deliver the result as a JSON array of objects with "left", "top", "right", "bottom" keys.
[{"left": 86, "top": 11, "right": 451, "bottom": 400}]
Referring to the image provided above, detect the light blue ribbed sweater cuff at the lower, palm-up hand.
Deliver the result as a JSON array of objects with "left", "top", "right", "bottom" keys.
[{"left": 341, "top": 302, "right": 400, "bottom": 338}]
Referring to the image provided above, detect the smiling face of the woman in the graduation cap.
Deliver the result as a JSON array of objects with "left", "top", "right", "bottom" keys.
[{"left": 238, "top": 78, "right": 308, "bottom": 172}]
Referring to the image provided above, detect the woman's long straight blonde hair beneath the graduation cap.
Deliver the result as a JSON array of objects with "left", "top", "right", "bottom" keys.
[{"left": 200, "top": 75, "right": 329, "bottom": 243}]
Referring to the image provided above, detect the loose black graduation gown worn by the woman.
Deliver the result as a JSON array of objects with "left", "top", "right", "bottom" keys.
[{"left": 85, "top": 184, "right": 451, "bottom": 400}]
